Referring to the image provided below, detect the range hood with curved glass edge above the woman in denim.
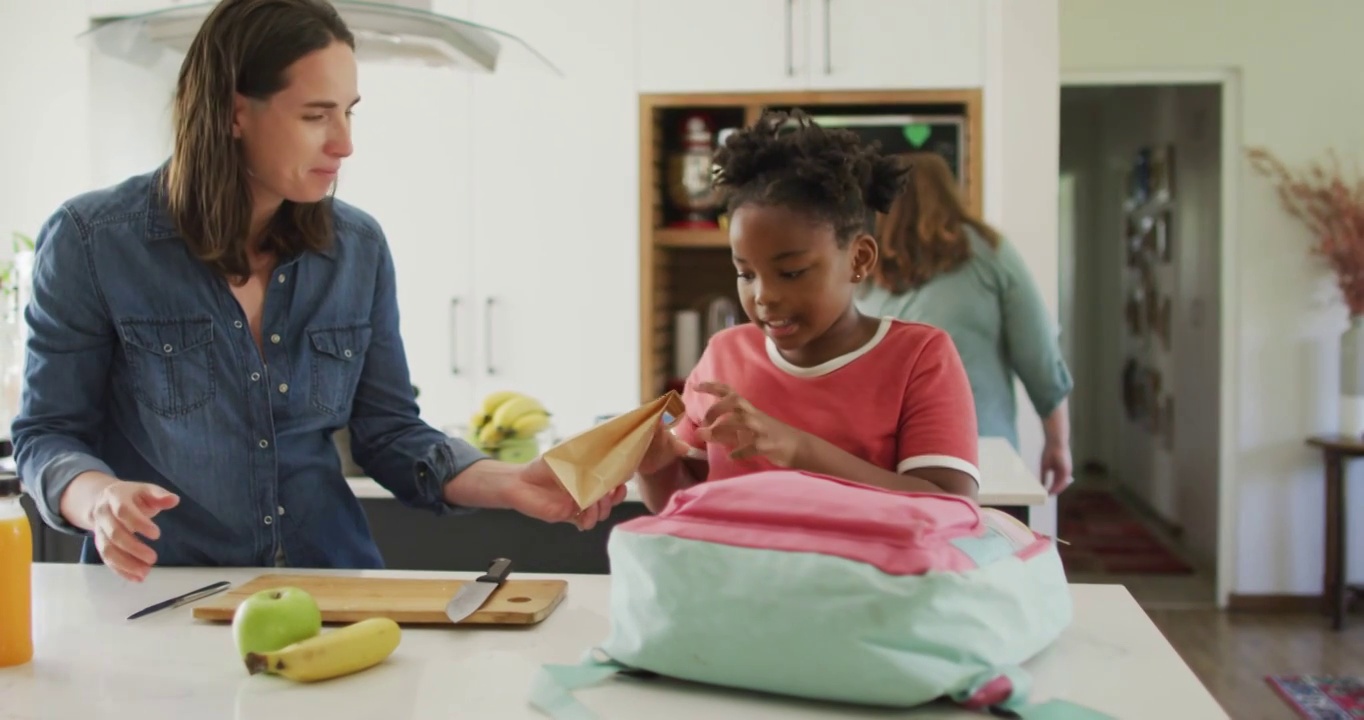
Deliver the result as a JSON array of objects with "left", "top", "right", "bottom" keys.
[{"left": 79, "top": 0, "right": 562, "bottom": 75}]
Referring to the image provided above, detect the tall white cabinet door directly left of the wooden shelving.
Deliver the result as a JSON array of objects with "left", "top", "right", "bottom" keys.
[{"left": 469, "top": 0, "right": 638, "bottom": 434}]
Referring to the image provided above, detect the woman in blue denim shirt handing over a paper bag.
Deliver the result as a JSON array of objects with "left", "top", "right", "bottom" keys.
[{"left": 12, "top": 0, "right": 625, "bottom": 581}]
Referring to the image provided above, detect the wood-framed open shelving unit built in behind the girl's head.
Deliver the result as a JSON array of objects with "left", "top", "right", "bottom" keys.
[{"left": 640, "top": 90, "right": 983, "bottom": 402}]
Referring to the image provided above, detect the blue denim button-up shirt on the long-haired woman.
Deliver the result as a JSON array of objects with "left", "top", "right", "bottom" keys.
[{"left": 12, "top": 166, "right": 486, "bottom": 567}]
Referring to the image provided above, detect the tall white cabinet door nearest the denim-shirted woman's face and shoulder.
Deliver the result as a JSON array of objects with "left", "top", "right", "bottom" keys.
[{"left": 336, "top": 56, "right": 477, "bottom": 428}]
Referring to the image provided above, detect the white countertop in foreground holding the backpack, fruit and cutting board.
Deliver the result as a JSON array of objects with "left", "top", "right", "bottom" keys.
[{"left": 0, "top": 565, "right": 1226, "bottom": 720}]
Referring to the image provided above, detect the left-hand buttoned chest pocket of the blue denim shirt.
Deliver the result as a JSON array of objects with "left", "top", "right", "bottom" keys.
[{"left": 120, "top": 318, "right": 217, "bottom": 417}]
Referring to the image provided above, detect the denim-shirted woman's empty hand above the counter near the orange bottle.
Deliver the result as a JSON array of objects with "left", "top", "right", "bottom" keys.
[{"left": 90, "top": 481, "right": 180, "bottom": 582}]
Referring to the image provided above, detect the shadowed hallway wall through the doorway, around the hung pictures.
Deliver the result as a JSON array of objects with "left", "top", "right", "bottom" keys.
[{"left": 1061, "top": 86, "right": 1221, "bottom": 569}]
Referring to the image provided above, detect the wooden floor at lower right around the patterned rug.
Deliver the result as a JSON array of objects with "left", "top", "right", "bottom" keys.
[{"left": 1147, "top": 607, "right": 1364, "bottom": 720}]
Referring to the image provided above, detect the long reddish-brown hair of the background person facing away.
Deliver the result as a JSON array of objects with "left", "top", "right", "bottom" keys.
[{"left": 873, "top": 153, "right": 1000, "bottom": 293}]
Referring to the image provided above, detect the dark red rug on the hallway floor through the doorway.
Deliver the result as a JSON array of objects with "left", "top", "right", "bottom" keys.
[{"left": 1057, "top": 487, "right": 1194, "bottom": 575}]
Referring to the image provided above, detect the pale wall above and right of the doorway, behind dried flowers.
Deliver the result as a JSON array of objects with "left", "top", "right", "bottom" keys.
[{"left": 1061, "top": 0, "right": 1364, "bottom": 595}]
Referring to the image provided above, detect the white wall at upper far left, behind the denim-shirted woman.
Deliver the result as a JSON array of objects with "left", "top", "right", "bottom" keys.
[{"left": 0, "top": 0, "right": 90, "bottom": 258}]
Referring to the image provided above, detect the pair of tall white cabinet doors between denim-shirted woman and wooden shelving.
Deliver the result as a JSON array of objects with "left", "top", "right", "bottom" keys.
[{"left": 351, "top": 0, "right": 638, "bottom": 434}]
